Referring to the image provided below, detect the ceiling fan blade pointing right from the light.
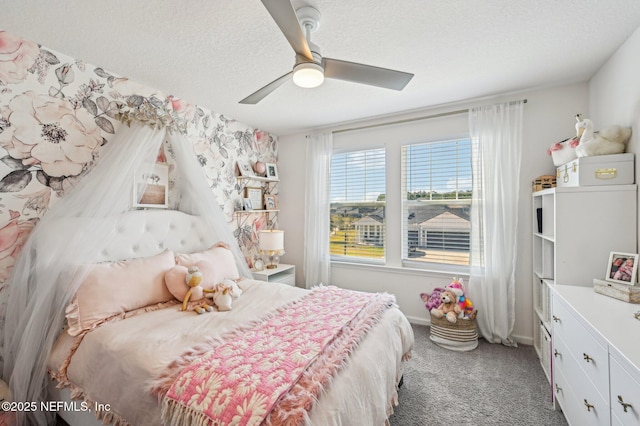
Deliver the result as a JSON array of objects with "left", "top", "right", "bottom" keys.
[{"left": 322, "top": 58, "right": 413, "bottom": 90}]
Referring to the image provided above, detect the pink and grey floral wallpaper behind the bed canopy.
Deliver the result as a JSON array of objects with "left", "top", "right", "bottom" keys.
[{"left": 0, "top": 30, "right": 277, "bottom": 309}]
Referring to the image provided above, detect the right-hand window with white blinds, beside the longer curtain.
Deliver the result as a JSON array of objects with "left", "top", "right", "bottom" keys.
[{"left": 402, "top": 139, "right": 471, "bottom": 265}]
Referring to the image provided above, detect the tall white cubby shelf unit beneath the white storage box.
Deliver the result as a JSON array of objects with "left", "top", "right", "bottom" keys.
[{"left": 532, "top": 185, "right": 637, "bottom": 392}]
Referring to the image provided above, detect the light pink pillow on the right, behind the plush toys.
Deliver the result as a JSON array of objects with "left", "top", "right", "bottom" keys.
[{"left": 176, "top": 246, "right": 240, "bottom": 288}]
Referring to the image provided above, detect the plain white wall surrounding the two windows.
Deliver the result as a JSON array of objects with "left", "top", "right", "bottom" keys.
[{"left": 278, "top": 83, "right": 588, "bottom": 344}]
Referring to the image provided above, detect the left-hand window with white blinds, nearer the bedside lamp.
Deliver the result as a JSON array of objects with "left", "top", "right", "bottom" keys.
[{"left": 329, "top": 148, "right": 386, "bottom": 262}]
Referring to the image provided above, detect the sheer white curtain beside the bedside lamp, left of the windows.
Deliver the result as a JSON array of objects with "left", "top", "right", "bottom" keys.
[{"left": 304, "top": 133, "right": 333, "bottom": 288}]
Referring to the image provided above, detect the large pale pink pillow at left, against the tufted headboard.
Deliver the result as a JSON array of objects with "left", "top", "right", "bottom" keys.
[{"left": 66, "top": 250, "right": 175, "bottom": 336}]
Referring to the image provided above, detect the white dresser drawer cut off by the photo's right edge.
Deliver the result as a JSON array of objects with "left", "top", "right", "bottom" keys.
[{"left": 609, "top": 355, "right": 640, "bottom": 425}]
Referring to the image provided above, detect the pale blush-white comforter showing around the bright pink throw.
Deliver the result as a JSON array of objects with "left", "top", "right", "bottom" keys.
[{"left": 49, "top": 280, "right": 413, "bottom": 426}]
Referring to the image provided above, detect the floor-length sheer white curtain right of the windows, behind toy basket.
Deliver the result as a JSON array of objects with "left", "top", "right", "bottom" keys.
[{"left": 468, "top": 101, "right": 524, "bottom": 346}]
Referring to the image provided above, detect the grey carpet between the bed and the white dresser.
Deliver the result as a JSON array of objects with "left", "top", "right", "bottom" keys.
[{"left": 389, "top": 325, "right": 567, "bottom": 426}]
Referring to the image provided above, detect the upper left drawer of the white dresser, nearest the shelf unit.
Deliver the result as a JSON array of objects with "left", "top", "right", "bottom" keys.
[{"left": 552, "top": 298, "right": 609, "bottom": 401}]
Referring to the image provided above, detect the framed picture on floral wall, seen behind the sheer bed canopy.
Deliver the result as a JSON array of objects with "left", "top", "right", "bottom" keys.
[{"left": 133, "top": 163, "right": 169, "bottom": 209}]
